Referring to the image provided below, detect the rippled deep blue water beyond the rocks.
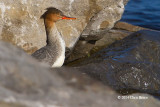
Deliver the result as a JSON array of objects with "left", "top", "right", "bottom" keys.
[{"left": 121, "top": 0, "right": 160, "bottom": 30}]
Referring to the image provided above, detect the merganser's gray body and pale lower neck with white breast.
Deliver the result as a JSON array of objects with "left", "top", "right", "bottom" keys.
[{"left": 32, "top": 26, "right": 65, "bottom": 67}]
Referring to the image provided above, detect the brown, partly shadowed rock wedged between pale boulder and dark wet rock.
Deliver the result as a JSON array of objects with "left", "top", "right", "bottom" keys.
[{"left": 65, "top": 22, "right": 146, "bottom": 64}]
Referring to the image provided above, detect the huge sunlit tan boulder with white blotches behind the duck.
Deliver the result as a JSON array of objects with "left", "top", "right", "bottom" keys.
[{"left": 0, "top": 0, "right": 128, "bottom": 53}]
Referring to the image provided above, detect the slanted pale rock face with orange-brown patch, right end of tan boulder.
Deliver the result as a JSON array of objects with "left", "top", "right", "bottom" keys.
[{"left": 81, "top": 0, "right": 129, "bottom": 36}]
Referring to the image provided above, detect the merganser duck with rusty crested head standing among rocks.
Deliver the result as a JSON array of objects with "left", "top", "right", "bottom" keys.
[{"left": 31, "top": 7, "right": 76, "bottom": 67}]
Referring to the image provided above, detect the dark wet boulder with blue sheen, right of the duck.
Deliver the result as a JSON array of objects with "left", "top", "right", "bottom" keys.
[{"left": 70, "top": 30, "right": 160, "bottom": 94}]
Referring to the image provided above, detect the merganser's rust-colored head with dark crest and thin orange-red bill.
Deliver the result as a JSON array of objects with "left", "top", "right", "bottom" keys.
[{"left": 41, "top": 7, "right": 76, "bottom": 22}]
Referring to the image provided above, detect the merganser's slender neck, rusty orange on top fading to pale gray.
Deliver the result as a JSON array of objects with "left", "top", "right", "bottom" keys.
[{"left": 44, "top": 20, "right": 64, "bottom": 46}]
